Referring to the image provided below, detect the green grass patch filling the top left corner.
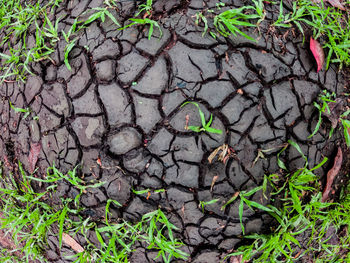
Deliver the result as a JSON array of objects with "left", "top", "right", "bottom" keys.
[{"left": 0, "top": 0, "right": 120, "bottom": 80}]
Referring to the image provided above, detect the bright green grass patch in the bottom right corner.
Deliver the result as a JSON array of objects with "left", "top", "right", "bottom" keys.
[{"left": 227, "top": 141, "right": 350, "bottom": 262}]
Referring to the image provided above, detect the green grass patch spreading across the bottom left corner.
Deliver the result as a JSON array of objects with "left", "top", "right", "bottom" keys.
[{"left": 0, "top": 163, "right": 189, "bottom": 263}]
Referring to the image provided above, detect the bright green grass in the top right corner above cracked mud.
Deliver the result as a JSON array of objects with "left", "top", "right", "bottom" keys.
[{"left": 195, "top": 0, "right": 350, "bottom": 69}]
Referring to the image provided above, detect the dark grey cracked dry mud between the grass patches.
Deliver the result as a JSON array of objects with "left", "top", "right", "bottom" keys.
[{"left": 0, "top": 0, "right": 344, "bottom": 263}]
